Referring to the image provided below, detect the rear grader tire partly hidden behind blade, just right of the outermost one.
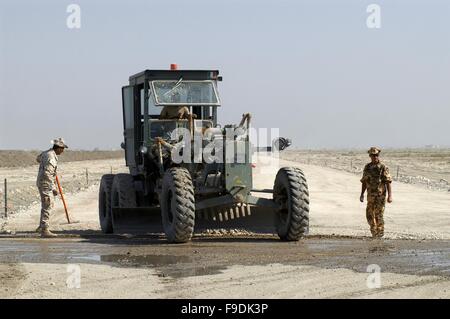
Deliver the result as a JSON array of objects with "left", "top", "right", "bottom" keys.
[{"left": 111, "top": 174, "right": 136, "bottom": 230}]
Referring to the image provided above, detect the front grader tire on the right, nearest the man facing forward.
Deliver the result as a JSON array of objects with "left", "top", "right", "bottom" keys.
[{"left": 273, "top": 167, "right": 309, "bottom": 241}]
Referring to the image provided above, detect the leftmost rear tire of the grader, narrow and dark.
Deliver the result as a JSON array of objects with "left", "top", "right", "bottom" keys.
[{"left": 98, "top": 174, "right": 114, "bottom": 234}]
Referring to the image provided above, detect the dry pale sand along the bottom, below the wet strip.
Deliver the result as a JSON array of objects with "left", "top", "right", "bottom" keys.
[{"left": 0, "top": 264, "right": 450, "bottom": 299}]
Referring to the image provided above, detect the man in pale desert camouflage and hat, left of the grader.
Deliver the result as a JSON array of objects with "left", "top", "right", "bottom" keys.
[{"left": 36, "top": 138, "right": 68, "bottom": 238}]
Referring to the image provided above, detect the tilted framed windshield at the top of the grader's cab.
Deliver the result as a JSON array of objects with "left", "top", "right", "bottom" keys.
[{"left": 150, "top": 78, "right": 220, "bottom": 106}]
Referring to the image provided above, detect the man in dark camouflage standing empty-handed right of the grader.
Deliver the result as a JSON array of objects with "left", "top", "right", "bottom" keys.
[{"left": 360, "top": 147, "right": 392, "bottom": 238}]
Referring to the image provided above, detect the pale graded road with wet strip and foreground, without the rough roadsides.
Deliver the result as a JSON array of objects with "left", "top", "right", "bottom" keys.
[{"left": 0, "top": 155, "right": 450, "bottom": 298}]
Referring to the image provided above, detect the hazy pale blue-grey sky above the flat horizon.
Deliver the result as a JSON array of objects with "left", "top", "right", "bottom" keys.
[{"left": 0, "top": 0, "right": 450, "bottom": 149}]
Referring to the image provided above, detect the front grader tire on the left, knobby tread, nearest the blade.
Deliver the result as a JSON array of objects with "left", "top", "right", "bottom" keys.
[{"left": 160, "top": 167, "right": 195, "bottom": 243}]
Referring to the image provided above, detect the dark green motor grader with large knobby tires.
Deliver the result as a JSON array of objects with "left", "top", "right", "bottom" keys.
[{"left": 99, "top": 69, "right": 309, "bottom": 243}]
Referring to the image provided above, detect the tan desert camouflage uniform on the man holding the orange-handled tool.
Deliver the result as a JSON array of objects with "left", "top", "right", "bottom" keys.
[{"left": 36, "top": 149, "right": 58, "bottom": 229}]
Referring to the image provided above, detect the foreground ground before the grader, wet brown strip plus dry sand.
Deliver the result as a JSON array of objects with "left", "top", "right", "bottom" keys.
[{"left": 0, "top": 237, "right": 450, "bottom": 299}]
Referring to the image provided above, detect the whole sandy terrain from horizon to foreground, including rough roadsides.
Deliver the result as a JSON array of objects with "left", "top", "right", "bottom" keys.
[{"left": 0, "top": 150, "right": 450, "bottom": 298}]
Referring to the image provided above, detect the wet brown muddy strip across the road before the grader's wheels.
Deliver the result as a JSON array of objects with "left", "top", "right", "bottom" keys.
[{"left": 0, "top": 237, "right": 450, "bottom": 278}]
